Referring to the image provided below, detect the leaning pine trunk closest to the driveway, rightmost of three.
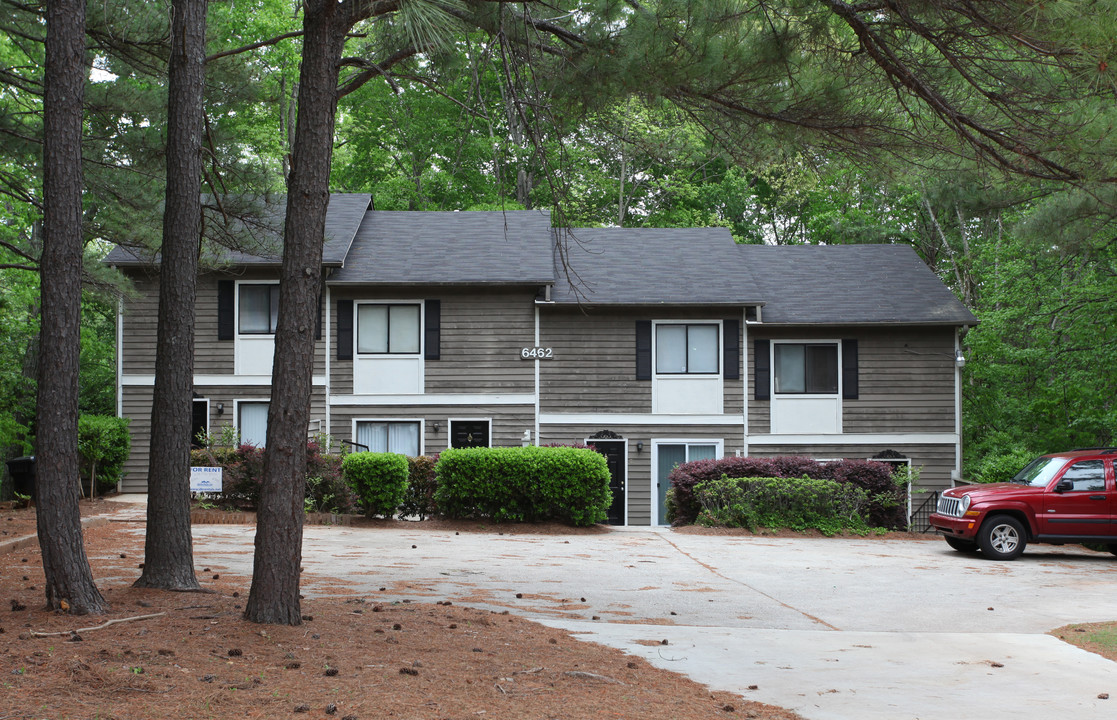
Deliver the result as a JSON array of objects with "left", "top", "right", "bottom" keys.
[{"left": 245, "top": 0, "right": 352, "bottom": 625}]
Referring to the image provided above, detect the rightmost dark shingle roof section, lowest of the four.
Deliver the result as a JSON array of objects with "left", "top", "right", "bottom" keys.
[{"left": 737, "top": 244, "right": 977, "bottom": 325}]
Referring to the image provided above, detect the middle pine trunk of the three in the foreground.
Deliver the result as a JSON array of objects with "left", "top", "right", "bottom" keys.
[{"left": 135, "top": 0, "right": 207, "bottom": 591}]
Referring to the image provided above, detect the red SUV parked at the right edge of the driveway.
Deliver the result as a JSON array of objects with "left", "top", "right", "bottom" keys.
[{"left": 930, "top": 448, "right": 1117, "bottom": 560}]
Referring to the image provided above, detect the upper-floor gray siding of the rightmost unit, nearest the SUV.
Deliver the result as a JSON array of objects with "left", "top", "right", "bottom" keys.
[{"left": 746, "top": 325, "right": 955, "bottom": 434}]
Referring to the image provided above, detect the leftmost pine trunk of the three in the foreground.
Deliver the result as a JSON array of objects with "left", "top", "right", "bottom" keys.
[{"left": 36, "top": 0, "right": 107, "bottom": 615}]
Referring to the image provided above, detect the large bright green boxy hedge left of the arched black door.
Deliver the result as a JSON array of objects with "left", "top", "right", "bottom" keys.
[{"left": 435, "top": 447, "right": 612, "bottom": 526}]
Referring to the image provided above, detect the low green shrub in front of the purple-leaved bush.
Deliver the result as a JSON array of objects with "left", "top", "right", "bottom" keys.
[{"left": 694, "top": 477, "right": 870, "bottom": 535}]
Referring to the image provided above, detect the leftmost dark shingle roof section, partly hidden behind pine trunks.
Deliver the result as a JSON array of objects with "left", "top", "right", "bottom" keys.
[{"left": 104, "top": 193, "right": 372, "bottom": 267}]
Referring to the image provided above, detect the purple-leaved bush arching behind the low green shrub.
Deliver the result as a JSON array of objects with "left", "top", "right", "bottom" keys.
[{"left": 667, "top": 455, "right": 906, "bottom": 529}]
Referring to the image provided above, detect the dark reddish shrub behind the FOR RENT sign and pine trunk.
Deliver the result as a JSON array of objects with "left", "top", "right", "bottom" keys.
[{"left": 190, "top": 442, "right": 356, "bottom": 512}]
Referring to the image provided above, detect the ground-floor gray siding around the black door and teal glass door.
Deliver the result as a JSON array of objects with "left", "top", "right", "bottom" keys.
[{"left": 540, "top": 421, "right": 743, "bottom": 526}]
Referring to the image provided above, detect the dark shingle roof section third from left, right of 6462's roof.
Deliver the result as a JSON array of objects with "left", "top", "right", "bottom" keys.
[{"left": 552, "top": 228, "right": 764, "bottom": 306}]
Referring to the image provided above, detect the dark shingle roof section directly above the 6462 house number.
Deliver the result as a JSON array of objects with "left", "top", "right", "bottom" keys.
[{"left": 330, "top": 210, "right": 554, "bottom": 285}]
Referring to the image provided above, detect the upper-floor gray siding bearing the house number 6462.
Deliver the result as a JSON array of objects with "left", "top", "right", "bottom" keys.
[{"left": 330, "top": 287, "right": 535, "bottom": 395}]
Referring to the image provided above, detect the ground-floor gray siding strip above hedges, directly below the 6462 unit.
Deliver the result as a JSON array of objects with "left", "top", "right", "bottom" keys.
[{"left": 330, "top": 405, "right": 535, "bottom": 455}]
